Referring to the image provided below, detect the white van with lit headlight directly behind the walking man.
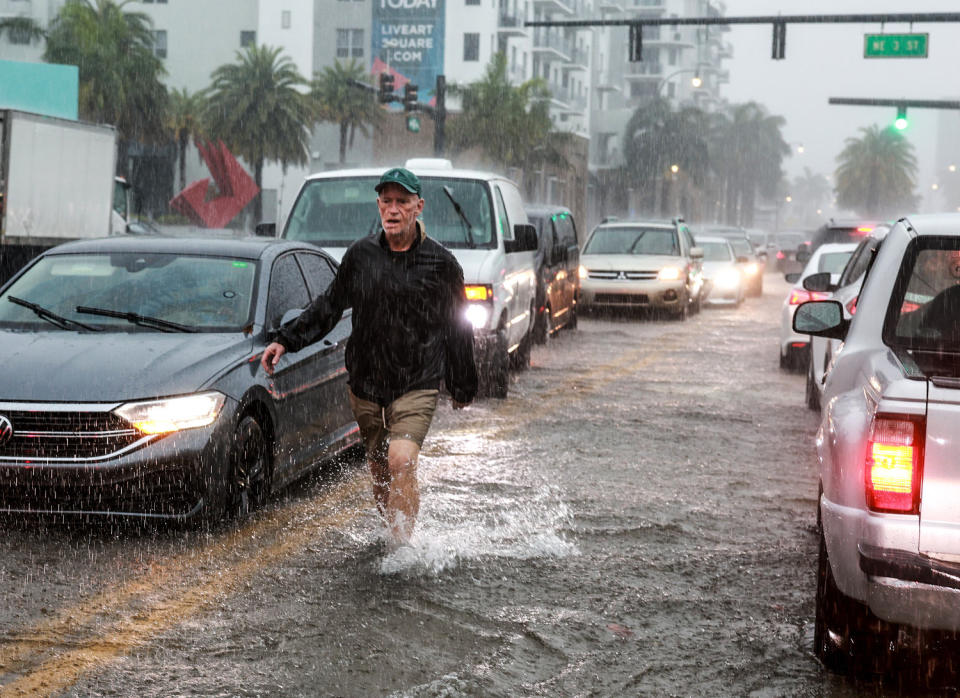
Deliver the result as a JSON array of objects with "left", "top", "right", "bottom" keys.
[{"left": 280, "top": 159, "right": 537, "bottom": 398}]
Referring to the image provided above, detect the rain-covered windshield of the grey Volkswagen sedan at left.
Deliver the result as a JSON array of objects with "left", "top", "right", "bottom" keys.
[{"left": 0, "top": 252, "right": 257, "bottom": 332}]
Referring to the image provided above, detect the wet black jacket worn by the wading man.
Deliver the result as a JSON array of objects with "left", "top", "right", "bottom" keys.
[{"left": 277, "top": 221, "right": 477, "bottom": 407}]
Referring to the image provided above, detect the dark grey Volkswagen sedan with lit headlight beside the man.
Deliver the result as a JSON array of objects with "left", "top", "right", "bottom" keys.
[{"left": 0, "top": 237, "right": 359, "bottom": 519}]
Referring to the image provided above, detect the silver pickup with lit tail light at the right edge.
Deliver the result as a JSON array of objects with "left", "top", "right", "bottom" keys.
[{"left": 793, "top": 214, "right": 960, "bottom": 673}]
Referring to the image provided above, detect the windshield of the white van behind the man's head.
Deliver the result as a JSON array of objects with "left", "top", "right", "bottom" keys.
[{"left": 283, "top": 176, "right": 497, "bottom": 248}]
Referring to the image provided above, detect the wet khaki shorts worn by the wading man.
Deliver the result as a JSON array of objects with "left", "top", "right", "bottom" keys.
[{"left": 347, "top": 388, "right": 440, "bottom": 457}]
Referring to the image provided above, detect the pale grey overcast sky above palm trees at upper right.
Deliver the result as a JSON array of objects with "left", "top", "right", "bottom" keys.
[{"left": 723, "top": 0, "right": 960, "bottom": 208}]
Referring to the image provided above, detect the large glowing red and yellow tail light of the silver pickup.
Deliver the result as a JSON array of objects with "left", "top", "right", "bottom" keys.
[{"left": 866, "top": 415, "right": 924, "bottom": 514}]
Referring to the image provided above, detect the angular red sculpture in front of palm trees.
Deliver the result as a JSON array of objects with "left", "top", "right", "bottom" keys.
[{"left": 170, "top": 141, "right": 260, "bottom": 228}]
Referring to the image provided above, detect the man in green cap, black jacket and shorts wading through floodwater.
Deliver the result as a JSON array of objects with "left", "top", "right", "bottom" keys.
[{"left": 260, "top": 167, "right": 477, "bottom": 544}]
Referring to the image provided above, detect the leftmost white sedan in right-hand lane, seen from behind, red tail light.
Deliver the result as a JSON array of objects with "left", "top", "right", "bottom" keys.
[{"left": 780, "top": 242, "right": 857, "bottom": 369}]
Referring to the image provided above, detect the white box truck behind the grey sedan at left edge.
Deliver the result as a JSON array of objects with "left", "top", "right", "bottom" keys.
[{"left": 0, "top": 109, "right": 119, "bottom": 283}]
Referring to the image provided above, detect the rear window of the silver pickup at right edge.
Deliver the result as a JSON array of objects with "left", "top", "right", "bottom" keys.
[{"left": 885, "top": 238, "right": 960, "bottom": 354}]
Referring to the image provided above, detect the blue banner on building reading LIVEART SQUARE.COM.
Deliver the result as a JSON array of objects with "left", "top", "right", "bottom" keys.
[{"left": 370, "top": 0, "right": 446, "bottom": 104}]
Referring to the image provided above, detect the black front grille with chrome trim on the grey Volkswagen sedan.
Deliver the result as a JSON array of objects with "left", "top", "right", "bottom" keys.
[{"left": 0, "top": 404, "right": 151, "bottom": 461}]
